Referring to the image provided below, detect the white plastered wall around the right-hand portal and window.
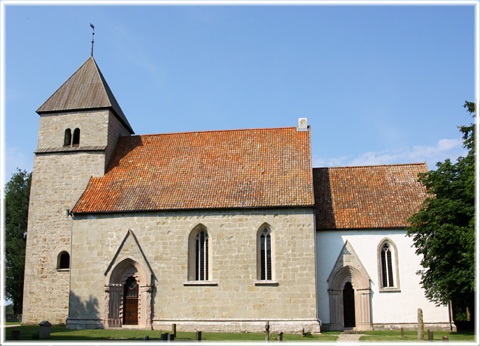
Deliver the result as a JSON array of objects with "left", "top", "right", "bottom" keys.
[{"left": 316, "top": 230, "right": 449, "bottom": 324}]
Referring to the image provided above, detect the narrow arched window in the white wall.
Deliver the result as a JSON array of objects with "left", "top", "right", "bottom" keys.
[{"left": 378, "top": 239, "right": 400, "bottom": 291}]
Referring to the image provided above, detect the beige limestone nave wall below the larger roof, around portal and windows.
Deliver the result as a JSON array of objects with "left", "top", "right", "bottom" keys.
[{"left": 67, "top": 208, "right": 319, "bottom": 332}]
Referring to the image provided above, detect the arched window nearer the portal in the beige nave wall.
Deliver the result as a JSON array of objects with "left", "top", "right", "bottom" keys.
[{"left": 188, "top": 225, "right": 210, "bottom": 281}]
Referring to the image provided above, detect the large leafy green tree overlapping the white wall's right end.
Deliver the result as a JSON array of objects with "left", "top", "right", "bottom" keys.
[{"left": 408, "top": 102, "right": 475, "bottom": 324}]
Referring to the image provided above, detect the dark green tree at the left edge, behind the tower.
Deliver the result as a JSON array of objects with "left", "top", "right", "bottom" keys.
[{"left": 5, "top": 169, "right": 32, "bottom": 314}]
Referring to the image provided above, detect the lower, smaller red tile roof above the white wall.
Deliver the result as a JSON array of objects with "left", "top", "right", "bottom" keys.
[{"left": 313, "top": 164, "right": 427, "bottom": 229}]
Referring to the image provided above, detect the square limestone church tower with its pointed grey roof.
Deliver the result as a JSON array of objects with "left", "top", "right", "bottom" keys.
[{"left": 22, "top": 57, "right": 134, "bottom": 324}]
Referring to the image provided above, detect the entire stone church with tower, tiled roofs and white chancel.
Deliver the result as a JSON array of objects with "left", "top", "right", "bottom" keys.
[{"left": 23, "top": 57, "right": 451, "bottom": 333}]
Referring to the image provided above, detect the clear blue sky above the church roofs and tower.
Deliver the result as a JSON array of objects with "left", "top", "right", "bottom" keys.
[{"left": 2, "top": 4, "right": 475, "bottom": 180}]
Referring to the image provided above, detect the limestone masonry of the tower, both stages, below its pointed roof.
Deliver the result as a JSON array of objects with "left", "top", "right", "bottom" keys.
[{"left": 22, "top": 110, "right": 128, "bottom": 324}]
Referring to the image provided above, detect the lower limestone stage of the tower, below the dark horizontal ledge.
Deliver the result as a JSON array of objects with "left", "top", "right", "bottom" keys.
[{"left": 22, "top": 152, "right": 105, "bottom": 324}]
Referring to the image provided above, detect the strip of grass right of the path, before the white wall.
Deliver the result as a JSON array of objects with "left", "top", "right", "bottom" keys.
[{"left": 360, "top": 330, "right": 475, "bottom": 342}]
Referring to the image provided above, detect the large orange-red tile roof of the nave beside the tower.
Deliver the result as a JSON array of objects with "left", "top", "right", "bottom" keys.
[{"left": 72, "top": 128, "right": 314, "bottom": 213}]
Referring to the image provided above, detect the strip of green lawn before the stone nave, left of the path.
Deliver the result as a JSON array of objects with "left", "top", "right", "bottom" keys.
[{"left": 6, "top": 326, "right": 339, "bottom": 342}]
